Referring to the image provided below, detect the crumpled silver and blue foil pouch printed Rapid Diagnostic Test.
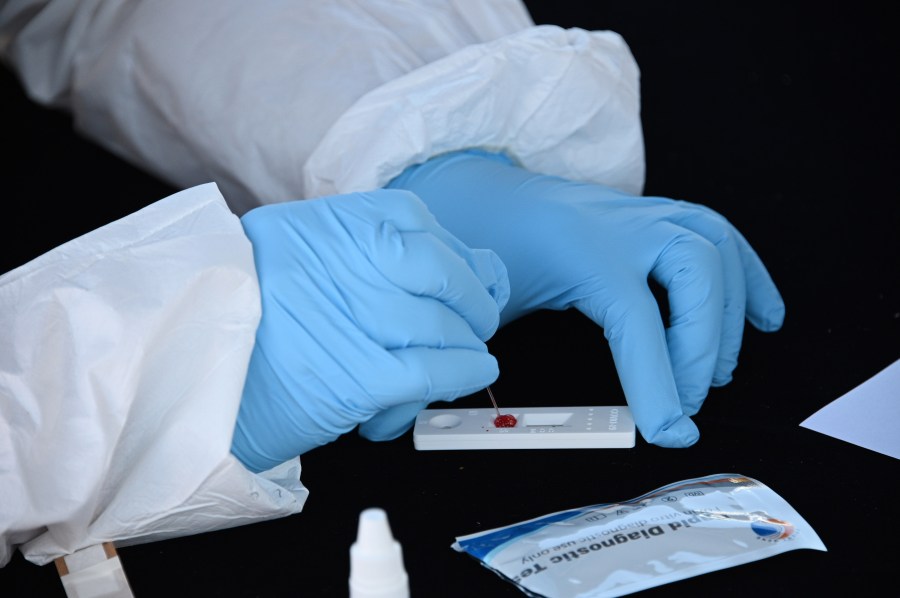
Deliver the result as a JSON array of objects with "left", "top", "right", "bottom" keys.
[{"left": 453, "top": 474, "right": 826, "bottom": 598}]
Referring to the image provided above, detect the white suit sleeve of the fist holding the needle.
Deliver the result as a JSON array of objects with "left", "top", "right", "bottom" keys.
[{"left": 0, "top": 183, "right": 307, "bottom": 566}]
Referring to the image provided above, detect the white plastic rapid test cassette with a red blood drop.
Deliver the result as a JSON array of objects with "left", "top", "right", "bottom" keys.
[{"left": 413, "top": 406, "right": 634, "bottom": 451}]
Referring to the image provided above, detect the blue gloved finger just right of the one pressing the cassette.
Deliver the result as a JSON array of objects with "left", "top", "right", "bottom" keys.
[{"left": 651, "top": 230, "right": 724, "bottom": 415}]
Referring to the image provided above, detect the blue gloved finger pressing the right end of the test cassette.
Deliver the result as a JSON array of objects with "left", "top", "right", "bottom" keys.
[{"left": 576, "top": 281, "right": 700, "bottom": 448}]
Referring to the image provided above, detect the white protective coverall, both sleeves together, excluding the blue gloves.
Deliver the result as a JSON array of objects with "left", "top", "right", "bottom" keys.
[{"left": 0, "top": 0, "right": 644, "bottom": 565}]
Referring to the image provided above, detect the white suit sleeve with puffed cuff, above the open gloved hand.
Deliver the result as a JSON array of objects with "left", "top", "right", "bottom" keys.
[{"left": 0, "top": 0, "right": 644, "bottom": 214}]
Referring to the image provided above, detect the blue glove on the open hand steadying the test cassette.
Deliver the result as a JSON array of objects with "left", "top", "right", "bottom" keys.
[{"left": 389, "top": 150, "right": 784, "bottom": 447}]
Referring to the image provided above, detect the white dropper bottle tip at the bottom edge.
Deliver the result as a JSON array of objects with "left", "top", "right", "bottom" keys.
[{"left": 350, "top": 508, "right": 409, "bottom": 598}]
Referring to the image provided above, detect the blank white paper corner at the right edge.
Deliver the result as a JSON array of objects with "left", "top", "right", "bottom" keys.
[{"left": 800, "top": 359, "right": 900, "bottom": 459}]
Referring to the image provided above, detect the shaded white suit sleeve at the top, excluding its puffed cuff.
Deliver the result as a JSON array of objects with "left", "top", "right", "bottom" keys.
[{"left": 0, "top": 0, "right": 532, "bottom": 215}]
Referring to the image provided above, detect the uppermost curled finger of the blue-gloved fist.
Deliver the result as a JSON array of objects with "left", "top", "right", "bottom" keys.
[{"left": 373, "top": 222, "right": 509, "bottom": 340}]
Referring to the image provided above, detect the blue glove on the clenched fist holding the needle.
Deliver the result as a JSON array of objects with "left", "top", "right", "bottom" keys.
[{"left": 232, "top": 190, "right": 509, "bottom": 471}]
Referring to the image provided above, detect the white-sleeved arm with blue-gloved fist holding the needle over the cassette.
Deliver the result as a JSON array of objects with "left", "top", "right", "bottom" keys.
[{"left": 0, "top": 184, "right": 508, "bottom": 566}]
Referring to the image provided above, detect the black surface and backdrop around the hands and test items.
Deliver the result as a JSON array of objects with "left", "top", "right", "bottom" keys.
[{"left": 0, "top": 0, "right": 900, "bottom": 597}]
